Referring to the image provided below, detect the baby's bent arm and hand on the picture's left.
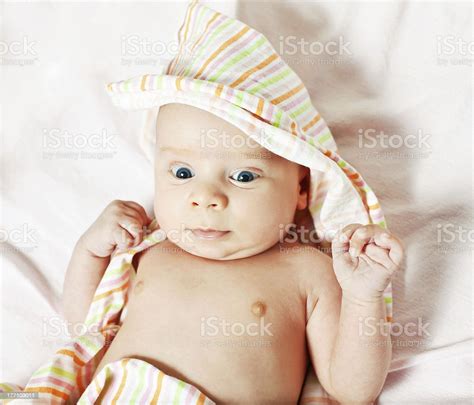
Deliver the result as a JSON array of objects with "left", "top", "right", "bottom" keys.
[{"left": 62, "top": 200, "right": 150, "bottom": 335}]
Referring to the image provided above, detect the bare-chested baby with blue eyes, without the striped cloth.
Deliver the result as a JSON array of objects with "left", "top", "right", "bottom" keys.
[{"left": 63, "top": 103, "right": 403, "bottom": 404}]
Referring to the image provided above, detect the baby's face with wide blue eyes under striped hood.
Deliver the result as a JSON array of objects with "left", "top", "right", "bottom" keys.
[{"left": 154, "top": 104, "right": 308, "bottom": 260}]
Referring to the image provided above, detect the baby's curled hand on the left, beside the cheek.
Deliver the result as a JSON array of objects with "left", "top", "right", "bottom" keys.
[{"left": 80, "top": 200, "right": 151, "bottom": 257}]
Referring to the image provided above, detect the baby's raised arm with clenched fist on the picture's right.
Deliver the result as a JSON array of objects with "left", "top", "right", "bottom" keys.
[{"left": 307, "top": 224, "right": 403, "bottom": 404}]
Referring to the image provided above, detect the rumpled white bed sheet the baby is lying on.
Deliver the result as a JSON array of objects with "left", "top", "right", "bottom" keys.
[{"left": 0, "top": 1, "right": 474, "bottom": 404}]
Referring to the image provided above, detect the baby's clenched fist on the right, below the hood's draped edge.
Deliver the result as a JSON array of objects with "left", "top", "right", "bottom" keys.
[{"left": 332, "top": 224, "right": 403, "bottom": 301}]
